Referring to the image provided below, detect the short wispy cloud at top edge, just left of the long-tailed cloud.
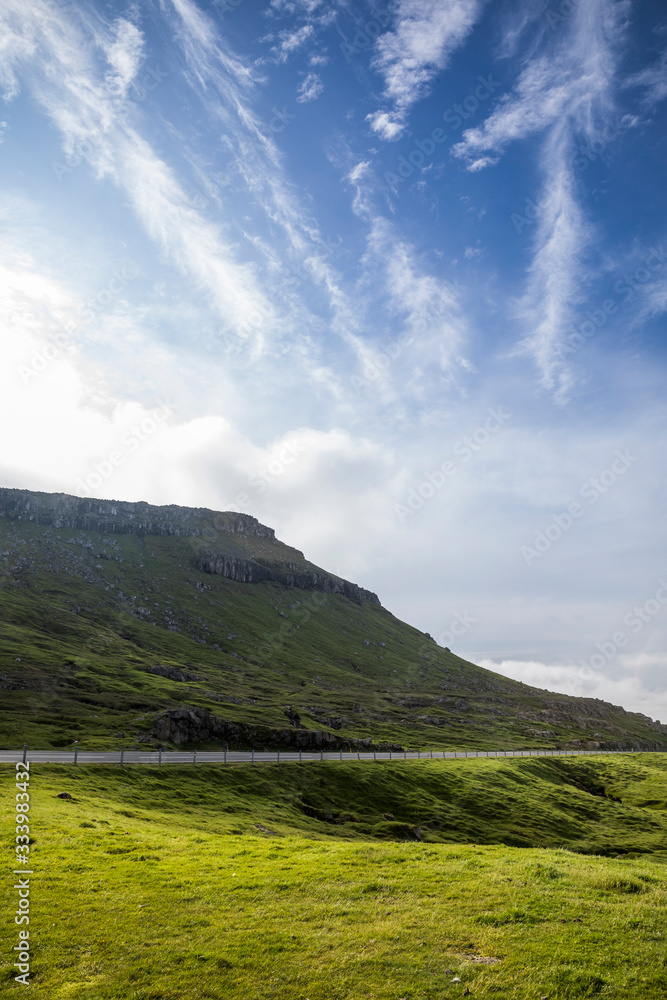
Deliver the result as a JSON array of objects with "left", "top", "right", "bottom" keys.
[{"left": 368, "top": 0, "right": 483, "bottom": 140}]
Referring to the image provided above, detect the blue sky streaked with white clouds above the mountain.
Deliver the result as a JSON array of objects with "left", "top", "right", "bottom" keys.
[{"left": 0, "top": 0, "right": 667, "bottom": 721}]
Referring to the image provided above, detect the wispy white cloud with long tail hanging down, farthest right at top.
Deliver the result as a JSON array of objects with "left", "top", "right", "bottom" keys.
[{"left": 453, "top": 0, "right": 627, "bottom": 400}]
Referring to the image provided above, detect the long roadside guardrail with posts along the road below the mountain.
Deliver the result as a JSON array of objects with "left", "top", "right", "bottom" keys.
[{"left": 0, "top": 746, "right": 667, "bottom": 767}]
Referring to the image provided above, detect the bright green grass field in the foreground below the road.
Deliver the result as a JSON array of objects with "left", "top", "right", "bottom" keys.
[{"left": 0, "top": 754, "right": 667, "bottom": 1000}]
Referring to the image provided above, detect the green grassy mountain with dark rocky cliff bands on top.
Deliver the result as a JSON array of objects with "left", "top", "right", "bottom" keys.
[{"left": 0, "top": 489, "right": 667, "bottom": 749}]
